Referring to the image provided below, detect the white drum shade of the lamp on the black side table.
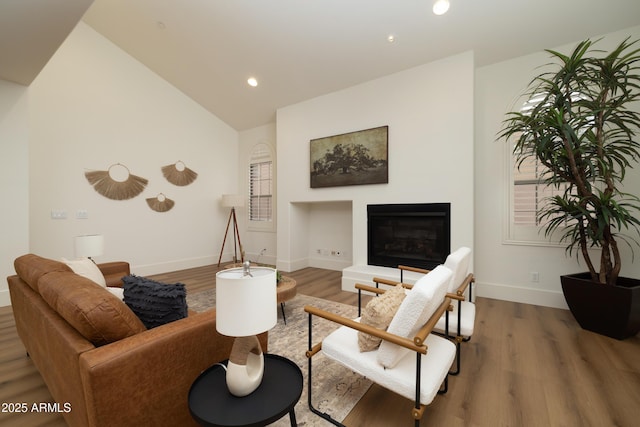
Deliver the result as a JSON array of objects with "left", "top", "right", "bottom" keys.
[{"left": 216, "top": 267, "right": 278, "bottom": 337}]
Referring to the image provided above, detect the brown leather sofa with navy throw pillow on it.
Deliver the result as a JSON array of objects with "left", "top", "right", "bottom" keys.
[{"left": 7, "top": 254, "right": 267, "bottom": 427}]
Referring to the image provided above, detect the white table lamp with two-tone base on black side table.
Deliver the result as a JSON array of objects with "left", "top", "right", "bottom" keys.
[{"left": 216, "top": 261, "right": 278, "bottom": 397}]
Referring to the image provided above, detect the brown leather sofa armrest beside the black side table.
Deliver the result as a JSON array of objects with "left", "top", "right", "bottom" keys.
[{"left": 80, "top": 310, "right": 267, "bottom": 427}]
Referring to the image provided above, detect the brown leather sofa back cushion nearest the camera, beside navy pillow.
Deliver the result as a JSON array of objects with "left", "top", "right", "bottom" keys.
[{"left": 39, "top": 271, "right": 146, "bottom": 346}]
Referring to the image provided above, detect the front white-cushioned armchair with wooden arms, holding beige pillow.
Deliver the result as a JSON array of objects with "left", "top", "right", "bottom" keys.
[{"left": 305, "top": 266, "right": 456, "bottom": 426}]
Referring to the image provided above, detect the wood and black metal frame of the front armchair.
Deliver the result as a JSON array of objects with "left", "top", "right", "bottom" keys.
[{"left": 304, "top": 283, "right": 453, "bottom": 427}]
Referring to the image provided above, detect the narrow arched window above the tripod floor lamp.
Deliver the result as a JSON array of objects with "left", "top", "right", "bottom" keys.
[{"left": 249, "top": 144, "right": 273, "bottom": 223}]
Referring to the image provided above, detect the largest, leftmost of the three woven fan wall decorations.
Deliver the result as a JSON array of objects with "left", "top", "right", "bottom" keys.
[{"left": 84, "top": 163, "right": 149, "bottom": 200}]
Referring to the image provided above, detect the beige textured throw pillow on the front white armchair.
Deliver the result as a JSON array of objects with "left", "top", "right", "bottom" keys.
[{"left": 358, "top": 285, "right": 405, "bottom": 351}]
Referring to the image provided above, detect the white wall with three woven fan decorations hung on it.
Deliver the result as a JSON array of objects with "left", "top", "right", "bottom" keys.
[{"left": 29, "top": 22, "right": 238, "bottom": 274}]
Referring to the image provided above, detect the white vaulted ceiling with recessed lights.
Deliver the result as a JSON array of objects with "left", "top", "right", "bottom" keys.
[{"left": 0, "top": 0, "right": 640, "bottom": 130}]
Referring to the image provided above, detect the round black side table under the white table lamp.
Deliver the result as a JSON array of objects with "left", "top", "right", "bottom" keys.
[{"left": 189, "top": 354, "right": 303, "bottom": 427}]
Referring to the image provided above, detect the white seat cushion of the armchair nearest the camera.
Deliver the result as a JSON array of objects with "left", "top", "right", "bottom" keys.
[{"left": 322, "top": 319, "right": 456, "bottom": 405}]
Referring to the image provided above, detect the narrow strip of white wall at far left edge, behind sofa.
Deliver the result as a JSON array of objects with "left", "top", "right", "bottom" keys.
[{"left": 0, "top": 80, "right": 29, "bottom": 306}]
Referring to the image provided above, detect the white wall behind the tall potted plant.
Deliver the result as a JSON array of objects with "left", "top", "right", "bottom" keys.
[{"left": 475, "top": 27, "right": 640, "bottom": 308}]
